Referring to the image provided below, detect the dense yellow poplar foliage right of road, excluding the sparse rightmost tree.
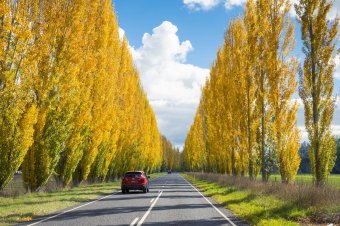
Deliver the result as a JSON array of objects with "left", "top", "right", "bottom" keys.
[{"left": 183, "top": 0, "right": 300, "bottom": 183}]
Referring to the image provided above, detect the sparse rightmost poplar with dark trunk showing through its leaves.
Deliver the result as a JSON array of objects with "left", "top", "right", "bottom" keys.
[{"left": 295, "top": 0, "right": 339, "bottom": 186}]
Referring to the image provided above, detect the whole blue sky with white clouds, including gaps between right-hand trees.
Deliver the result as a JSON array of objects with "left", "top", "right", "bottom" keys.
[{"left": 112, "top": 0, "right": 340, "bottom": 148}]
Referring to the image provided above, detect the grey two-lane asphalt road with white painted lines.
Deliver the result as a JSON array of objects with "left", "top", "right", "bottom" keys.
[{"left": 26, "top": 174, "right": 247, "bottom": 226}]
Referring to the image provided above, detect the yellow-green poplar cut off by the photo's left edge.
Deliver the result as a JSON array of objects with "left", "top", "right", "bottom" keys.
[{"left": 0, "top": 0, "right": 37, "bottom": 190}]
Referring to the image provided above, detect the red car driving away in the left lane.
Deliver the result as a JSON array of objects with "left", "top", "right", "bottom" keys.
[{"left": 121, "top": 171, "right": 149, "bottom": 193}]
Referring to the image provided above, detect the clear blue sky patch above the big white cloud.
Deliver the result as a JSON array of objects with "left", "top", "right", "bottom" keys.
[{"left": 113, "top": 0, "right": 243, "bottom": 68}]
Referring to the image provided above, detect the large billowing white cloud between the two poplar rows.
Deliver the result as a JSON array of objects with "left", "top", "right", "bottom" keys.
[{"left": 131, "top": 21, "right": 209, "bottom": 147}]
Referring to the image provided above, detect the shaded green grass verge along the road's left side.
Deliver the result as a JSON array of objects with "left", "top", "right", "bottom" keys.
[{"left": 0, "top": 173, "right": 164, "bottom": 225}]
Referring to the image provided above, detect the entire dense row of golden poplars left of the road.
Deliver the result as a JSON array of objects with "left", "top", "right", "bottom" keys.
[{"left": 0, "top": 0, "right": 163, "bottom": 191}]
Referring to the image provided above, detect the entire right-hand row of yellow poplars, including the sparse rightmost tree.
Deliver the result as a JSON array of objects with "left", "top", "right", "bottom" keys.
[{"left": 183, "top": 0, "right": 339, "bottom": 185}]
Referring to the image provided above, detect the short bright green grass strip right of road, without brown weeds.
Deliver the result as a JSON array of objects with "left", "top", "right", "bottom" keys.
[{"left": 184, "top": 175, "right": 313, "bottom": 226}]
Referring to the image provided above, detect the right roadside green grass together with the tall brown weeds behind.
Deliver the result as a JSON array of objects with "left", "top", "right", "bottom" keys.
[{"left": 186, "top": 173, "right": 340, "bottom": 225}]
